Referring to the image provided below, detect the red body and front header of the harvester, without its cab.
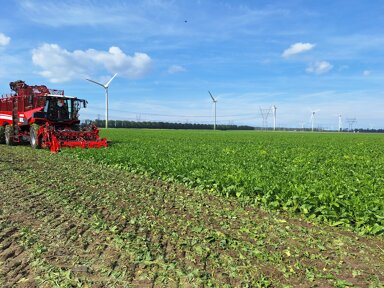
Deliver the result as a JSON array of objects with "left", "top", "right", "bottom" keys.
[{"left": 0, "top": 81, "right": 108, "bottom": 152}]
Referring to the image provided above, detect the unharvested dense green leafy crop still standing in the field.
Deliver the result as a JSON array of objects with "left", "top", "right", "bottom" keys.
[{"left": 65, "top": 129, "right": 384, "bottom": 235}]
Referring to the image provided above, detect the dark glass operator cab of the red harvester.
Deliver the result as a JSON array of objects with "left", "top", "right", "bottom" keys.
[{"left": 40, "top": 95, "right": 87, "bottom": 123}]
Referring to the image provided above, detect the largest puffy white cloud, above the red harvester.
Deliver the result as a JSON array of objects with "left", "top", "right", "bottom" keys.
[{"left": 32, "top": 43, "right": 152, "bottom": 83}]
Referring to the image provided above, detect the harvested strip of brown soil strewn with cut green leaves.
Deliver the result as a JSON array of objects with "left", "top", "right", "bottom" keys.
[{"left": 0, "top": 145, "right": 384, "bottom": 287}]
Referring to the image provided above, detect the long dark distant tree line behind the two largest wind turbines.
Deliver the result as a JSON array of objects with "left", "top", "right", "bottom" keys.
[{"left": 89, "top": 120, "right": 255, "bottom": 130}]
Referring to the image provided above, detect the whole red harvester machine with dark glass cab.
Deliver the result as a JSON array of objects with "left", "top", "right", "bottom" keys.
[{"left": 0, "top": 80, "right": 108, "bottom": 152}]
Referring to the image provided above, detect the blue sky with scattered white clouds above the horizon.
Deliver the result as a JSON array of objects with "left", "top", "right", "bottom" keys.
[{"left": 0, "top": 0, "right": 384, "bottom": 129}]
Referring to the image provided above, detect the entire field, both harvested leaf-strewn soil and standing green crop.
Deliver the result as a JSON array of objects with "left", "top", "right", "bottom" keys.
[{"left": 0, "top": 129, "right": 384, "bottom": 288}]
